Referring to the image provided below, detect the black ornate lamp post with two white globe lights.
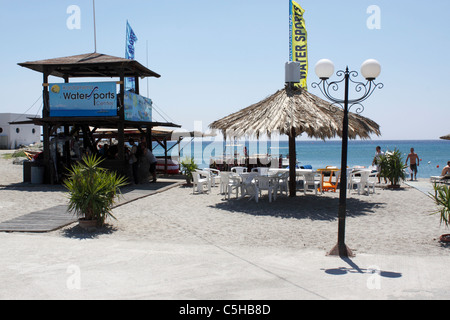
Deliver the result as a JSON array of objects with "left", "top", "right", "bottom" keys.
[{"left": 312, "top": 59, "right": 384, "bottom": 257}]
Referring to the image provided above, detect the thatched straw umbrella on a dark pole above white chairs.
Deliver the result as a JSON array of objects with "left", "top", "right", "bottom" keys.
[{"left": 209, "top": 86, "right": 381, "bottom": 197}]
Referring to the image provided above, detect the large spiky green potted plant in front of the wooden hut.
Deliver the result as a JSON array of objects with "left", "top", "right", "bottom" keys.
[{"left": 63, "top": 155, "right": 126, "bottom": 229}]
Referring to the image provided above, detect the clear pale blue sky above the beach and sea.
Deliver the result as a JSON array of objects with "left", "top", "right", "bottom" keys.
[{"left": 0, "top": 0, "right": 450, "bottom": 140}]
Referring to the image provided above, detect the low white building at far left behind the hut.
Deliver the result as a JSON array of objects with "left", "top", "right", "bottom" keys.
[{"left": 0, "top": 113, "right": 41, "bottom": 149}]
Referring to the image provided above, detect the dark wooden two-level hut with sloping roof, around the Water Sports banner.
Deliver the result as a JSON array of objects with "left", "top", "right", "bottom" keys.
[{"left": 19, "top": 53, "right": 181, "bottom": 184}]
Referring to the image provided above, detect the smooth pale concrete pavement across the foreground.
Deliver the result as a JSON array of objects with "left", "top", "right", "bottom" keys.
[{"left": 0, "top": 233, "right": 450, "bottom": 300}]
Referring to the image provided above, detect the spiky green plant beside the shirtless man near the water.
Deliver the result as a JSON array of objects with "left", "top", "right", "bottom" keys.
[{"left": 380, "top": 149, "right": 406, "bottom": 189}]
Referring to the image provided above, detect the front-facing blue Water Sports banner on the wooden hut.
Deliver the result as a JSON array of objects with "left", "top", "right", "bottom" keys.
[{"left": 49, "top": 82, "right": 117, "bottom": 117}]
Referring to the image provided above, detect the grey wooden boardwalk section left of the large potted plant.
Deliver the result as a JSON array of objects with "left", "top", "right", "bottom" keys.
[{"left": 0, "top": 205, "right": 77, "bottom": 232}]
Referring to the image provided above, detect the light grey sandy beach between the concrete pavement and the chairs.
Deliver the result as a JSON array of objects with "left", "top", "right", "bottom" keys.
[{"left": 0, "top": 152, "right": 450, "bottom": 299}]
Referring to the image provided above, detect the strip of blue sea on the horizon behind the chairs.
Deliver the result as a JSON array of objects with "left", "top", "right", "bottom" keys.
[{"left": 153, "top": 138, "right": 450, "bottom": 178}]
